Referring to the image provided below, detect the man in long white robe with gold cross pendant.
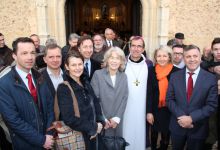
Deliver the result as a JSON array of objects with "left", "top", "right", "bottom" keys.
[{"left": 123, "top": 36, "right": 152, "bottom": 150}]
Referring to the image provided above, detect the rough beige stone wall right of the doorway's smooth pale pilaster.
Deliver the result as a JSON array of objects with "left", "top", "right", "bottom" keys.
[{"left": 169, "top": 0, "right": 220, "bottom": 48}]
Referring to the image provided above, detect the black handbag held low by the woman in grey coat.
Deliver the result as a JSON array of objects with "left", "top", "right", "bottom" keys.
[{"left": 99, "top": 131, "right": 129, "bottom": 150}]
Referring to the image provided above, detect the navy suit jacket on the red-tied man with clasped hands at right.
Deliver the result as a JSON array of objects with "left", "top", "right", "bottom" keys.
[{"left": 166, "top": 68, "right": 218, "bottom": 139}]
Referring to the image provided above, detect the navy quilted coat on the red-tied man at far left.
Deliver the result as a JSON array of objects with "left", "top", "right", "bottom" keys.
[{"left": 0, "top": 67, "right": 54, "bottom": 150}]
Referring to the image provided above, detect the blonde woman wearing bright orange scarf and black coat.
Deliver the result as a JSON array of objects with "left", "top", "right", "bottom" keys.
[{"left": 146, "top": 46, "right": 178, "bottom": 150}]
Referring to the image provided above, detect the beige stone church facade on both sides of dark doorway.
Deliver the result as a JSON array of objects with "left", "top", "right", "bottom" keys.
[{"left": 0, "top": 0, "right": 220, "bottom": 54}]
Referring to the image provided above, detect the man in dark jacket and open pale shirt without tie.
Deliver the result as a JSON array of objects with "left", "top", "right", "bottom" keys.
[{"left": 42, "top": 44, "right": 63, "bottom": 97}]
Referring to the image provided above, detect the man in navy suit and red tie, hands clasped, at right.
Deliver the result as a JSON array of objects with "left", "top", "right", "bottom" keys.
[{"left": 166, "top": 45, "right": 218, "bottom": 150}]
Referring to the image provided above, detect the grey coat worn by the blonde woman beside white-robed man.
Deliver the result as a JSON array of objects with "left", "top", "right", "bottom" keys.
[{"left": 91, "top": 68, "right": 128, "bottom": 136}]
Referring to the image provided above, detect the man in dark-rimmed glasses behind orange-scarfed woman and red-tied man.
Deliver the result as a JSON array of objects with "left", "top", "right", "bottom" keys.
[{"left": 172, "top": 45, "right": 185, "bottom": 69}]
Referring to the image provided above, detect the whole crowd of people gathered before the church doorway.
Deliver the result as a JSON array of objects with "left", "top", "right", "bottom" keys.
[{"left": 0, "top": 28, "right": 220, "bottom": 150}]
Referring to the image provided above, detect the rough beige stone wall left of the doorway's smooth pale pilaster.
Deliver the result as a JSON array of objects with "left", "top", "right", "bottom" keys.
[{"left": 0, "top": 0, "right": 37, "bottom": 47}]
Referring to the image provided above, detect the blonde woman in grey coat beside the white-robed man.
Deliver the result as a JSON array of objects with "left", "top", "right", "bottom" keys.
[{"left": 91, "top": 47, "right": 128, "bottom": 136}]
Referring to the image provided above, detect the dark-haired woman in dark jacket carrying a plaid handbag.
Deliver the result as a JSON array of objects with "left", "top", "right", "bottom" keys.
[{"left": 57, "top": 51, "right": 104, "bottom": 150}]
